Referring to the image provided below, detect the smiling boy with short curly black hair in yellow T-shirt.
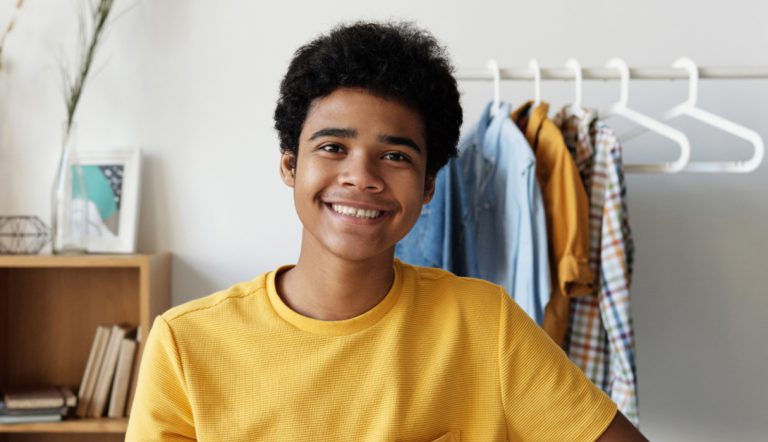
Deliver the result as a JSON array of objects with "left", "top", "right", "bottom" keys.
[{"left": 127, "top": 23, "right": 644, "bottom": 441}]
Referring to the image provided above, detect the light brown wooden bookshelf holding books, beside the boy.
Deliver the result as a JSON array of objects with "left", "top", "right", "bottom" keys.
[{"left": 0, "top": 254, "right": 171, "bottom": 442}]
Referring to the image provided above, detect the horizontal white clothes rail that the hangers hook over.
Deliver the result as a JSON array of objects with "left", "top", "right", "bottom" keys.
[{"left": 454, "top": 66, "right": 768, "bottom": 81}]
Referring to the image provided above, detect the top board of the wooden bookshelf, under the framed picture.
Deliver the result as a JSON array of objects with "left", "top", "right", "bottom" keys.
[{"left": 0, "top": 254, "right": 157, "bottom": 268}]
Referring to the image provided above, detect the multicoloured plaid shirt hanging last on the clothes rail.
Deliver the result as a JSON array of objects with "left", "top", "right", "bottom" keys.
[{"left": 557, "top": 108, "right": 639, "bottom": 425}]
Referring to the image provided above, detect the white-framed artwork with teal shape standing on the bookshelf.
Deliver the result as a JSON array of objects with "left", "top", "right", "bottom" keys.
[{"left": 72, "top": 148, "right": 141, "bottom": 253}]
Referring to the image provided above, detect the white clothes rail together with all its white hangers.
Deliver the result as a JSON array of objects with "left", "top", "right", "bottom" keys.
[{"left": 455, "top": 63, "right": 768, "bottom": 173}]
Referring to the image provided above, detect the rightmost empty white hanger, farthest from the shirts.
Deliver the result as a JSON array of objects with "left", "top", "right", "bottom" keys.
[{"left": 664, "top": 58, "right": 765, "bottom": 173}]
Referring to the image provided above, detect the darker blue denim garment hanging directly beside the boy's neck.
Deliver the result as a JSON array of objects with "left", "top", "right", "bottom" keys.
[{"left": 395, "top": 158, "right": 479, "bottom": 277}]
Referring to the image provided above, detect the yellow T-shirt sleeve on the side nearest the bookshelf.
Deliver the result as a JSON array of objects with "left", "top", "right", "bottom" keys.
[{"left": 125, "top": 316, "right": 196, "bottom": 441}]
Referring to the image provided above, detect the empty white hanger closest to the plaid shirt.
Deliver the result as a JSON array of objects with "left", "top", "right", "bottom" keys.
[{"left": 605, "top": 58, "right": 691, "bottom": 173}]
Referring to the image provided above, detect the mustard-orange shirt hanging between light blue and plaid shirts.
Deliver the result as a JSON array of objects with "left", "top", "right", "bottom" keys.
[{"left": 511, "top": 101, "right": 597, "bottom": 345}]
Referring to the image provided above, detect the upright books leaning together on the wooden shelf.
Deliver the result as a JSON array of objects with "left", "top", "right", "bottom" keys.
[{"left": 75, "top": 324, "right": 140, "bottom": 418}]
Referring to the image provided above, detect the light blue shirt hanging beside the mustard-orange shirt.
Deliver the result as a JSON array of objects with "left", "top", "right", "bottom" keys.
[{"left": 459, "top": 103, "right": 550, "bottom": 325}]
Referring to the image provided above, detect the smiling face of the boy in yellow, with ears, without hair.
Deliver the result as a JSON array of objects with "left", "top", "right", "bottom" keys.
[{"left": 280, "top": 88, "right": 433, "bottom": 261}]
